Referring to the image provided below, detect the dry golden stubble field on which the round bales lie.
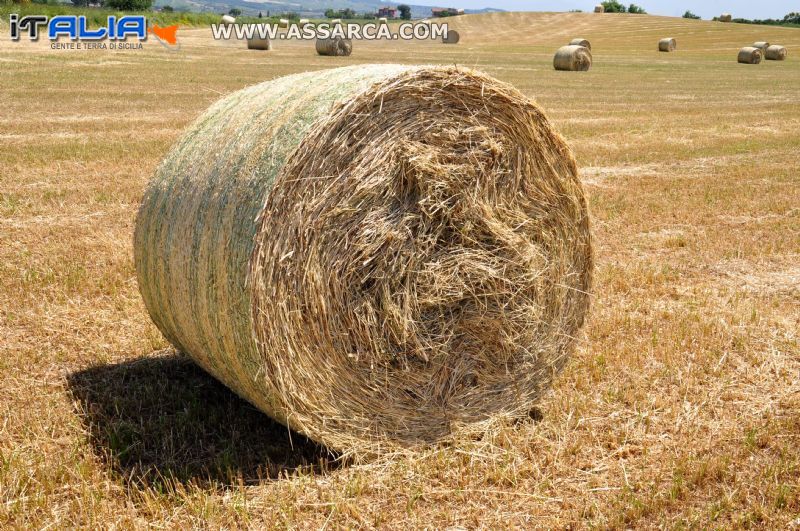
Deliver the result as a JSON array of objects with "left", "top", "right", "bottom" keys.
[{"left": 0, "top": 10, "right": 800, "bottom": 528}]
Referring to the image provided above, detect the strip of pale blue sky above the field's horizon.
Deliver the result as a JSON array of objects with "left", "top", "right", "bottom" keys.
[{"left": 408, "top": 0, "right": 800, "bottom": 19}]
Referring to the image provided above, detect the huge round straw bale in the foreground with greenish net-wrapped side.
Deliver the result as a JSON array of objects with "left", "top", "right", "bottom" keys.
[{"left": 134, "top": 65, "right": 592, "bottom": 450}]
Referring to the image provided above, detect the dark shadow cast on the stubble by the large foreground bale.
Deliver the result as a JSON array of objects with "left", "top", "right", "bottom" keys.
[{"left": 67, "top": 354, "right": 340, "bottom": 486}]
